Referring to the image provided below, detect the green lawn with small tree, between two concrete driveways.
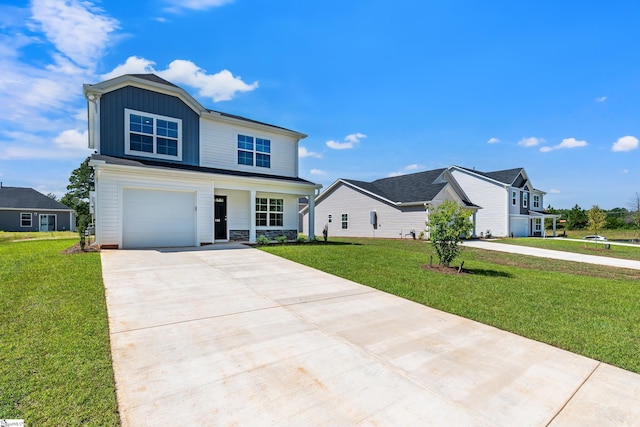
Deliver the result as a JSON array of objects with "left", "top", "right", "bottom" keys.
[{"left": 260, "top": 239, "right": 640, "bottom": 373}]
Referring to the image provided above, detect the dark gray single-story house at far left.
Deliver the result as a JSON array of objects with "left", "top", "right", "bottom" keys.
[{"left": 0, "top": 183, "right": 76, "bottom": 231}]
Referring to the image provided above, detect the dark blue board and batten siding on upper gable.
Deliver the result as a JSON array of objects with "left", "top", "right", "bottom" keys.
[{"left": 100, "top": 86, "right": 200, "bottom": 166}]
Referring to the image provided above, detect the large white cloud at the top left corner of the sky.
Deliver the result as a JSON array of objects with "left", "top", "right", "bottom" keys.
[{"left": 31, "top": 0, "right": 119, "bottom": 68}]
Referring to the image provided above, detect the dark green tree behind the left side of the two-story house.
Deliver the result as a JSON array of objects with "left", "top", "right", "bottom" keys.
[{"left": 60, "top": 157, "right": 95, "bottom": 249}]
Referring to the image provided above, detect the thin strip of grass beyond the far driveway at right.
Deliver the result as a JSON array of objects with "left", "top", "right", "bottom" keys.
[{"left": 498, "top": 237, "right": 640, "bottom": 260}]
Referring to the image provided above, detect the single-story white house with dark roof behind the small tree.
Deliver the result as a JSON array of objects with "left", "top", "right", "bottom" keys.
[{"left": 302, "top": 169, "right": 480, "bottom": 238}]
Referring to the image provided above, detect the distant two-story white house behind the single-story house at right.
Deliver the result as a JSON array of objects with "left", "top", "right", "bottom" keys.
[{"left": 449, "top": 166, "right": 559, "bottom": 237}]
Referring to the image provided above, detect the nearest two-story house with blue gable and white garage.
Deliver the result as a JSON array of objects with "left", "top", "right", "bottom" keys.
[{"left": 84, "top": 74, "right": 320, "bottom": 248}]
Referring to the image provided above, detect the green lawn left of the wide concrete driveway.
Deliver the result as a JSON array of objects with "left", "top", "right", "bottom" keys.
[{"left": 0, "top": 233, "right": 119, "bottom": 426}]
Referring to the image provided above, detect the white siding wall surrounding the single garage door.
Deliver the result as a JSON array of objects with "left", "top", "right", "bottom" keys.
[{"left": 95, "top": 167, "right": 213, "bottom": 247}]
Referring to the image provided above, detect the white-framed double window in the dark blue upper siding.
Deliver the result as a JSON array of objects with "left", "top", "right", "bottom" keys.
[{"left": 124, "top": 109, "right": 182, "bottom": 160}]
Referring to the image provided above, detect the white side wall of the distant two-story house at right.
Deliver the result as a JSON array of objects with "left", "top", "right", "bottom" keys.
[{"left": 451, "top": 169, "right": 511, "bottom": 236}]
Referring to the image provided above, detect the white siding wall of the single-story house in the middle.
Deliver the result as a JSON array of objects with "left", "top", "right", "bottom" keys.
[{"left": 303, "top": 185, "right": 426, "bottom": 238}]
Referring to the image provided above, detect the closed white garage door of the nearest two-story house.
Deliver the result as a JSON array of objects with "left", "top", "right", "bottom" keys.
[{"left": 122, "top": 188, "right": 196, "bottom": 248}]
